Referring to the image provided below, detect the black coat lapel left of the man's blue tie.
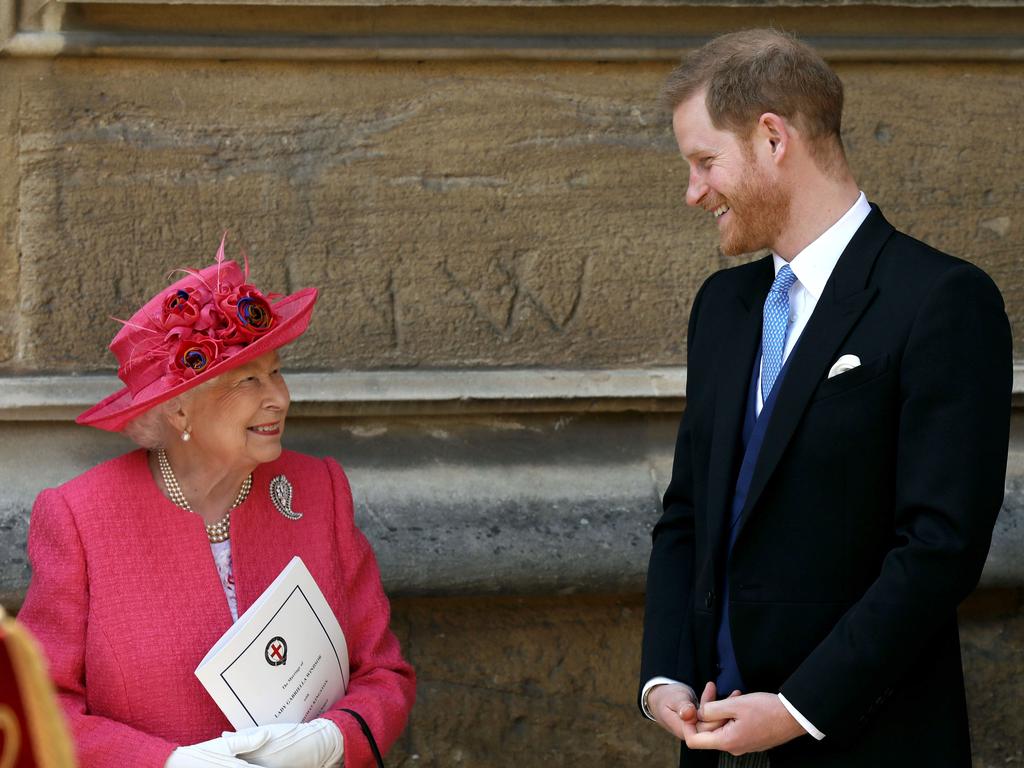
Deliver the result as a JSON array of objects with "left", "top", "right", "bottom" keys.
[{"left": 708, "top": 256, "right": 775, "bottom": 562}]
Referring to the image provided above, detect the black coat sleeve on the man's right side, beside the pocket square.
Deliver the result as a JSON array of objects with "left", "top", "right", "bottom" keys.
[{"left": 781, "top": 264, "right": 1013, "bottom": 740}]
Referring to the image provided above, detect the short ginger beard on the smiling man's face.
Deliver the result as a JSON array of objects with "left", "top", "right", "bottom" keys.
[{"left": 708, "top": 144, "right": 791, "bottom": 256}]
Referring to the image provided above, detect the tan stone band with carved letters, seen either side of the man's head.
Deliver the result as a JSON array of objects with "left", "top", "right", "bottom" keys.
[{"left": 6, "top": 59, "right": 1024, "bottom": 370}]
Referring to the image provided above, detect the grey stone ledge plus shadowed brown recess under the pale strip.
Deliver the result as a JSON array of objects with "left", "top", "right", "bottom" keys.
[{"left": 0, "top": 413, "right": 1024, "bottom": 605}]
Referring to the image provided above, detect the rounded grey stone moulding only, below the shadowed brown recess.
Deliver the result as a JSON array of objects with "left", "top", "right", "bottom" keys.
[{"left": 0, "top": 456, "right": 1024, "bottom": 605}]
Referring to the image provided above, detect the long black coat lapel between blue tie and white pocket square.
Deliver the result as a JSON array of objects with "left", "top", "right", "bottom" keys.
[{"left": 737, "top": 206, "right": 893, "bottom": 537}]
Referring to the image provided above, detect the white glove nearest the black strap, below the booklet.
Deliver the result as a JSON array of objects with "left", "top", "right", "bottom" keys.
[{"left": 222, "top": 718, "right": 345, "bottom": 768}]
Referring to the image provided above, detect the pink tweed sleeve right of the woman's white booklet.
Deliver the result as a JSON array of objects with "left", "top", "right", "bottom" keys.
[{"left": 323, "top": 460, "right": 416, "bottom": 768}]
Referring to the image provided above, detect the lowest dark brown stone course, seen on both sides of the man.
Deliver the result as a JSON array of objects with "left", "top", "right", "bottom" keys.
[{"left": 389, "top": 592, "right": 1024, "bottom": 768}]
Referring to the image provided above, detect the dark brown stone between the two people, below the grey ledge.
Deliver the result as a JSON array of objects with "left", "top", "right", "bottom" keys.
[{"left": 389, "top": 596, "right": 677, "bottom": 768}]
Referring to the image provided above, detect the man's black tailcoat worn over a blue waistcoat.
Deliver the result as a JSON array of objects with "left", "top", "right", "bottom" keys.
[{"left": 641, "top": 208, "right": 1013, "bottom": 768}]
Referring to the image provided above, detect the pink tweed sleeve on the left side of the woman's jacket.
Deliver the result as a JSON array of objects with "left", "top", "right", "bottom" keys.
[{"left": 17, "top": 488, "right": 176, "bottom": 768}]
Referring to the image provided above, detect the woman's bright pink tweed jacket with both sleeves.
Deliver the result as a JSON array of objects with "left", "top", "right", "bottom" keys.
[{"left": 18, "top": 451, "right": 416, "bottom": 768}]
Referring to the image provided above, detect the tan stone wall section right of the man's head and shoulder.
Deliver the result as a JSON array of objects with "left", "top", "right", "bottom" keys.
[{"left": 840, "top": 65, "right": 1024, "bottom": 342}]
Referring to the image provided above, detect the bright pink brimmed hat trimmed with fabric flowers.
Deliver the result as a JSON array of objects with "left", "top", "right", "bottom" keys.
[{"left": 76, "top": 236, "right": 316, "bottom": 432}]
